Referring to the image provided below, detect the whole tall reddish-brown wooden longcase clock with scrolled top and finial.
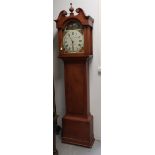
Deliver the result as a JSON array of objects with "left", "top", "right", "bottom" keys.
[{"left": 55, "top": 4, "right": 94, "bottom": 147}]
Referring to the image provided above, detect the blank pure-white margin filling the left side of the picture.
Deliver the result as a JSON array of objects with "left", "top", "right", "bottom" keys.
[{"left": 0, "top": 0, "right": 53, "bottom": 155}]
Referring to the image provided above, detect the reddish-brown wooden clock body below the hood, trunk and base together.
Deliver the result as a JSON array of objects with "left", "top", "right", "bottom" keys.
[{"left": 62, "top": 58, "right": 94, "bottom": 147}]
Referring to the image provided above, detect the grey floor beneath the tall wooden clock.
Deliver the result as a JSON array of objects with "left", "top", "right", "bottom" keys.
[{"left": 56, "top": 136, "right": 101, "bottom": 155}]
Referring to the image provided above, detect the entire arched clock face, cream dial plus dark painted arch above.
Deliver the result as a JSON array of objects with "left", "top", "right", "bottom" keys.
[{"left": 63, "top": 22, "right": 84, "bottom": 53}]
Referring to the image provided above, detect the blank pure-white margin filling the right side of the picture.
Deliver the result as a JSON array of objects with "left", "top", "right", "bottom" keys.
[{"left": 102, "top": 0, "right": 155, "bottom": 155}]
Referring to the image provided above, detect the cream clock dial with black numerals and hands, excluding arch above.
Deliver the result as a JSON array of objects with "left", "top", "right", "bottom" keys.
[{"left": 63, "top": 30, "right": 84, "bottom": 52}]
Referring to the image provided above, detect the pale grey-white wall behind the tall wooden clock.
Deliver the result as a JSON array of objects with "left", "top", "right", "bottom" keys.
[{"left": 53, "top": 0, "right": 101, "bottom": 139}]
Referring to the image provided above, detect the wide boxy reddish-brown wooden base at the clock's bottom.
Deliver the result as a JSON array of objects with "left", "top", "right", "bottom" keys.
[{"left": 62, "top": 115, "right": 95, "bottom": 148}]
